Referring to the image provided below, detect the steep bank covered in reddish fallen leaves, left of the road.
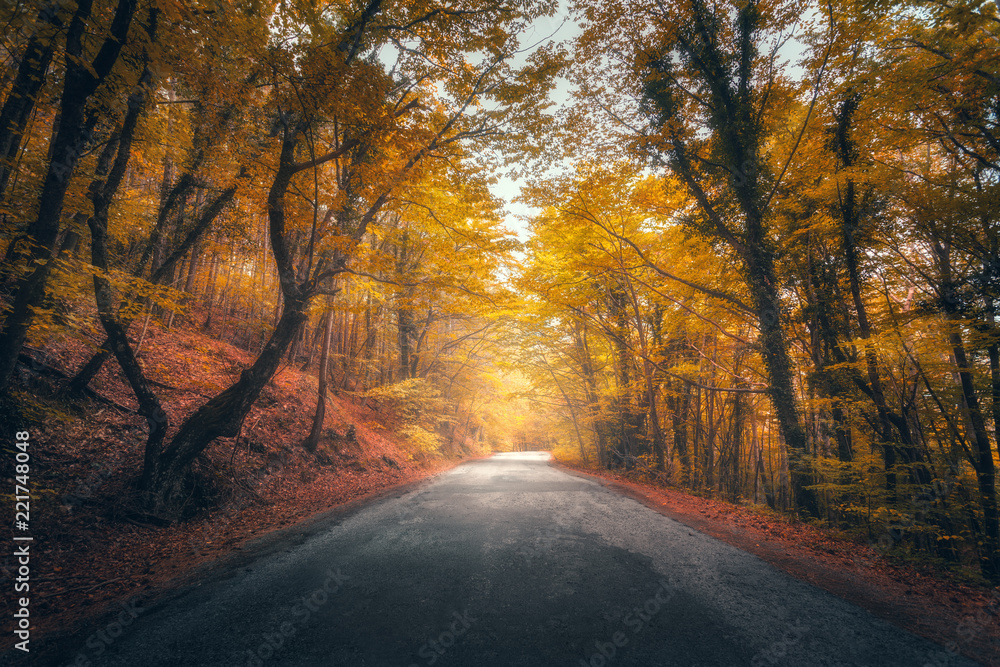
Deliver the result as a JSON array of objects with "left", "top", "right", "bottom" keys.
[{"left": 0, "top": 316, "right": 468, "bottom": 645}]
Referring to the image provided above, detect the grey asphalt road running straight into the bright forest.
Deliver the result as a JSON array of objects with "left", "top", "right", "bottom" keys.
[{"left": 43, "top": 453, "right": 974, "bottom": 667}]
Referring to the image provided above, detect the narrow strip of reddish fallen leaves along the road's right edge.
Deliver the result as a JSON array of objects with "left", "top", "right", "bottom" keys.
[{"left": 558, "top": 461, "right": 1000, "bottom": 667}]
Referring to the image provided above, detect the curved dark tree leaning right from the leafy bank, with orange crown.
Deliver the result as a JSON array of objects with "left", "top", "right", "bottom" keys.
[{"left": 143, "top": 0, "right": 560, "bottom": 513}]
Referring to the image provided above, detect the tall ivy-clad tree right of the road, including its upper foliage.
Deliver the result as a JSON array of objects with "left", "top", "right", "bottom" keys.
[{"left": 564, "top": 0, "right": 818, "bottom": 515}]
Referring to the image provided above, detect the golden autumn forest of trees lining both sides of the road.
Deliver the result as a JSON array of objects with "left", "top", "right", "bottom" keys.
[{"left": 0, "top": 0, "right": 1000, "bottom": 608}]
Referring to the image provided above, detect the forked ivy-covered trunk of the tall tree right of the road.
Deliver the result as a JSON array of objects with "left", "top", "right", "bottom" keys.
[{"left": 644, "top": 2, "right": 819, "bottom": 516}]
